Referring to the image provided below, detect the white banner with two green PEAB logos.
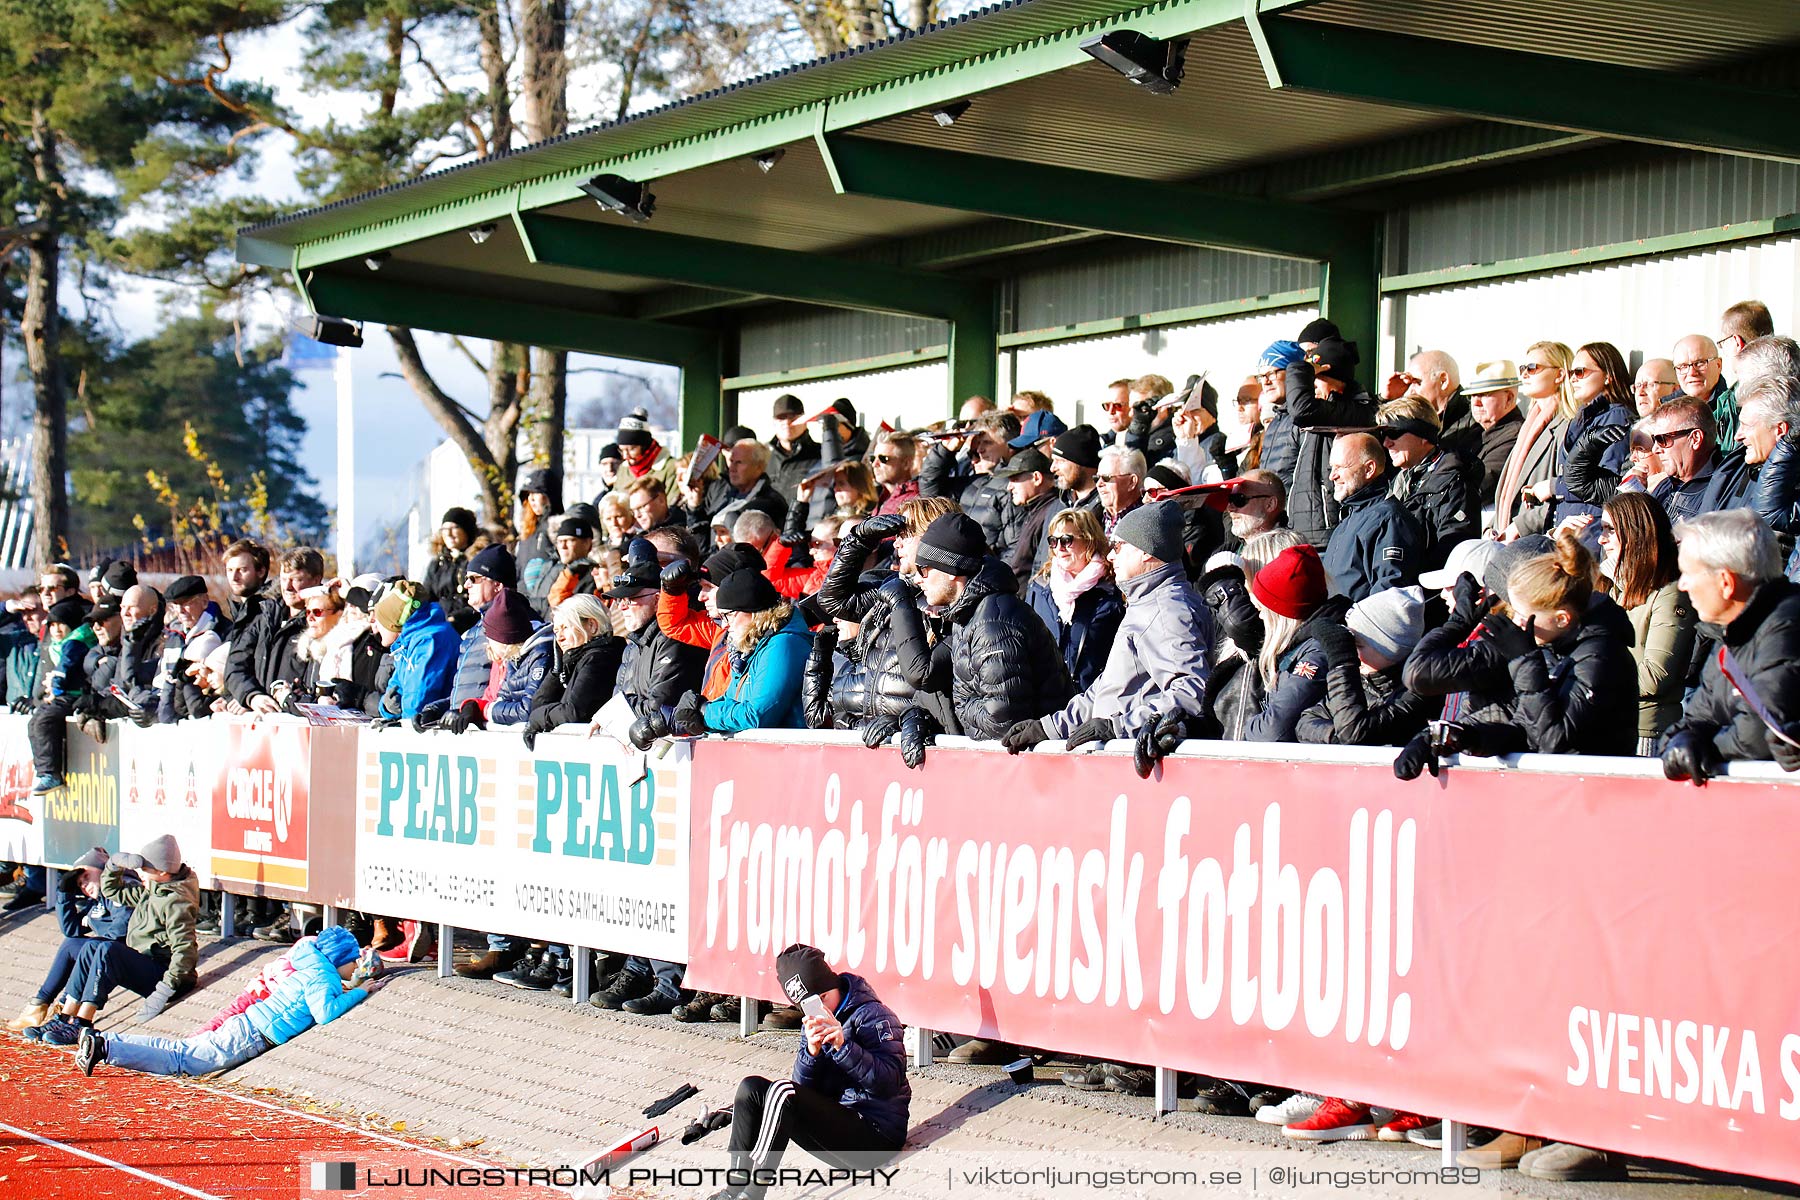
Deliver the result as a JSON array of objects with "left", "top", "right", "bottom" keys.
[{"left": 355, "top": 730, "right": 688, "bottom": 963}]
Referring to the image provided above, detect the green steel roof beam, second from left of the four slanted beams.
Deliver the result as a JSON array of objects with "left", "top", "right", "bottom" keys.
[{"left": 515, "top": 212, "right": 992, "bottom": 320}]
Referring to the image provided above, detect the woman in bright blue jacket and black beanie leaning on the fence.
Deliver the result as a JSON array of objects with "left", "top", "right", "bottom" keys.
[{"left": 670, "top": 567, "right": 812, "bottom": 736}]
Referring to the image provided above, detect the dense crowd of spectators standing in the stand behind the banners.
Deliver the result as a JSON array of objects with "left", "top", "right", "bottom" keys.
[{"left": 0, "top": 302, "right": 1800, "bottom": 1173}]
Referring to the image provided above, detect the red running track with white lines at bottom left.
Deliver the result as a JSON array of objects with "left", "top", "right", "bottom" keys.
[{"left": 0, "top": 1040, "right": 576, "bottom": 1200}]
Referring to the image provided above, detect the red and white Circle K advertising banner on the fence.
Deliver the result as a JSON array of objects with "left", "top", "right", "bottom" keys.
[{"left": 209, "top": 721, "right": 313, "bottom": 892}]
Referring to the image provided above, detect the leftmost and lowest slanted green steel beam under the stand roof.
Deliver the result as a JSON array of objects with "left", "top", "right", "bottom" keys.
[{"left": 306, "top": 272, "right": 718, "bottom": 365}]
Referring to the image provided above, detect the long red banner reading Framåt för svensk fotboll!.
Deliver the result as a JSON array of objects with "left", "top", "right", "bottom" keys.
[{"left": 688, "top": 741, "right": 1800, "bottom": 1180}]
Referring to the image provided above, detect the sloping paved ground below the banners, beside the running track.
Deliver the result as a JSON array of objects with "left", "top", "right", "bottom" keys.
[{"left": 0, "top": 910, "right": 1800, "bottom": 1200}]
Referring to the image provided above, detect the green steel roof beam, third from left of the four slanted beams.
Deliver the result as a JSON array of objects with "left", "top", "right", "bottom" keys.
[{"left": 819, "top": 135, "right": 1373, "bottom": 259}]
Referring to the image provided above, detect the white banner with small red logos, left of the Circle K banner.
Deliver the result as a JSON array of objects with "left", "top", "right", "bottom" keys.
[{"left": 112, "top": 721, "right": 216, "bottom": 887}]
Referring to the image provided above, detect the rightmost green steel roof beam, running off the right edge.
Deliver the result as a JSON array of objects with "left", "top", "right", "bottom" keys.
[{"left": 1246, "top": 13, "right": 1800, "bottom": 162}]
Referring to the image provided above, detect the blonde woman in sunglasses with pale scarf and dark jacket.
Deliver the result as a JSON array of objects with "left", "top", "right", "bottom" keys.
[{"left": 1026, "top": 509, "right": 1125, "bottom": 691}]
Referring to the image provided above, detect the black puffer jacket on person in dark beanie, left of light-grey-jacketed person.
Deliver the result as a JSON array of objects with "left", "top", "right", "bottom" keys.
[{"left": 914, "top": 556, "right": 1075, "bottom": 741}]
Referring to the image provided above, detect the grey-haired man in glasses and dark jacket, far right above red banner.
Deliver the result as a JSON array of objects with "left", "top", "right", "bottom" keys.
[{"left": 1663, "top": 509, "right": 1800, "bottom": 784}]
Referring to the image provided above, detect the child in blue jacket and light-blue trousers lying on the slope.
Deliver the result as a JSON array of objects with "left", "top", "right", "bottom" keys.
[{"left": 76, "top": 927, "right": 387, "bottom": 1076}]
